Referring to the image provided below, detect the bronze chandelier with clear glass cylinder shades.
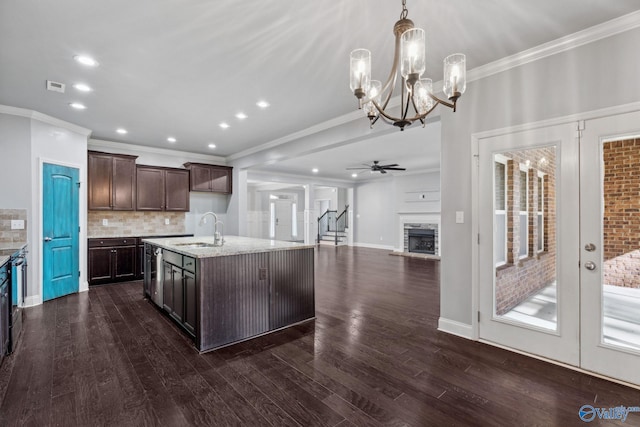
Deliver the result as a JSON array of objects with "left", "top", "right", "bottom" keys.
[{"left": 350, "top": 0, "right": 467, "bottom": 130}]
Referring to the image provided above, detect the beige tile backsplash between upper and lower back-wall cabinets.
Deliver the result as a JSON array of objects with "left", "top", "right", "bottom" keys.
[{"left": 87, "top": 211, "right": 185, "bottom": 238}]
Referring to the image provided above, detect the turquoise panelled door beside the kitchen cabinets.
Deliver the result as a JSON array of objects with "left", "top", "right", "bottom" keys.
[{"left": 42, "top": 163, "right": 80, "bottom": 301}]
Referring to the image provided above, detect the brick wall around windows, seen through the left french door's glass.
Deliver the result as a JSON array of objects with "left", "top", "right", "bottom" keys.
[{"left": 495, "top": 147, "right": 556, "bottom": 315}]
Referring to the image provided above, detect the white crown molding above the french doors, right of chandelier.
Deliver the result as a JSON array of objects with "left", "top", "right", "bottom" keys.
[{"left": 464, "top": 10, "right": 640, "bottom": 86}]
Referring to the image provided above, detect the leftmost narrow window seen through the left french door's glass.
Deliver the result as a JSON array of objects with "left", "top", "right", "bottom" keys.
[{"left": 493, "top": 160, "right": 507, "bottom": 267}]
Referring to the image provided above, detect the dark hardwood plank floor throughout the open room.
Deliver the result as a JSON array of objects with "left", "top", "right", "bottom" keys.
[{"left": 0, "top": 247, "right": 640, "bottom": 426}]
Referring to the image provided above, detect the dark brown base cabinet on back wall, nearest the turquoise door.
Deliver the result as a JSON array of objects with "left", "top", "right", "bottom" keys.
[{"left": 89, "top": 237, "right": 138, "bottom": 285}]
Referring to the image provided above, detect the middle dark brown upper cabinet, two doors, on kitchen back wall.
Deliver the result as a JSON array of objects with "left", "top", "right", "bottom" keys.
[{"left": 136, "top": 166, "right": 189, "bottom": 212}]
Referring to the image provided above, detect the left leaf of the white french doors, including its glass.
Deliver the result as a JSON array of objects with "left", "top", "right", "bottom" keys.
[{"left": 477, "top": 124, "right": 580, "bottom": 366}]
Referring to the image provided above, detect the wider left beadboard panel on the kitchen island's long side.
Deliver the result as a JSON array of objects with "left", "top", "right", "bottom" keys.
[{"left": 196, "top": 252, "right": 269, "bottom": 351}]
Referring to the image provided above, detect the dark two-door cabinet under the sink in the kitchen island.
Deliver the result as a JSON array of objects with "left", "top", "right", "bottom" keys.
[{"left": 162, "top": 250, "right": 196, "bottom": 336}]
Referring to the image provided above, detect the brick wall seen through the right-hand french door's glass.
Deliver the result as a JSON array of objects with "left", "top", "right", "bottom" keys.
[{"left": 602, "top": 139, "right": 640, "bottom": 288}]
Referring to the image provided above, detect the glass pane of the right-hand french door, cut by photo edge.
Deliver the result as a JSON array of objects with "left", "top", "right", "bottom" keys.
[{"left": 602, "top": 138, "right": 640, "bottom": 350}]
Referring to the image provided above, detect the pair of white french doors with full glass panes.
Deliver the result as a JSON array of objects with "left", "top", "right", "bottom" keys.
[{"left": 477, "top": 113, "right": 640, "bottom": 384}]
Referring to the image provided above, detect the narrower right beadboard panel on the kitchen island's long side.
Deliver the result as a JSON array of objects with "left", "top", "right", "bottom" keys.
[{"left": 269, "top": 248, "right": 315, "bottom": 330}]
